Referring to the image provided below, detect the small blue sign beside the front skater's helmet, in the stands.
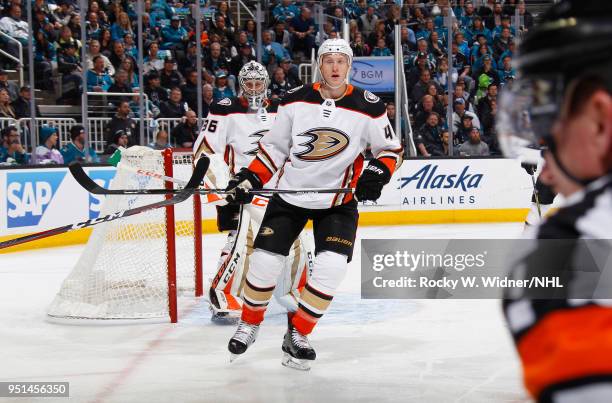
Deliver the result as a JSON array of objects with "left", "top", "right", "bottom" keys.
[{"left": 351, "top": 56, "right": 395, "bottom": 93}]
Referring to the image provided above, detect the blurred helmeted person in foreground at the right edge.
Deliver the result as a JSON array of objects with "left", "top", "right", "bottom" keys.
[{"left": 498, "top": 0, "right": 612, "bottom": 403}]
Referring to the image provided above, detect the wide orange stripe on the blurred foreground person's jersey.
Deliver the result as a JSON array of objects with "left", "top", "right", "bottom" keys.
[{"left": 517, "top": 306, "right": 612, "bottom": 398}]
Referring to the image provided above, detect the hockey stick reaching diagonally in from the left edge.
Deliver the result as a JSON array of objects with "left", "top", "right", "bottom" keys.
[{"left": 0, "top": 158, "right": 210, "bottom": 249}]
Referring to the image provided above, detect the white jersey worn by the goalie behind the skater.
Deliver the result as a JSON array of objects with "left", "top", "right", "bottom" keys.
[{"left": 193, "top": 98, "right": 278, "bottom": 187}]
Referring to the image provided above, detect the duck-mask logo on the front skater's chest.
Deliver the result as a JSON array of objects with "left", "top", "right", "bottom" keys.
[{"left": 294, "top": 127, "right": 349, "bottom": 161}]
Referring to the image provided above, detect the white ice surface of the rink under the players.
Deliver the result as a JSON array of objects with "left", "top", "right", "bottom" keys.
[{"left": 0, "top": 224, "right": 528, "bottom": 403}]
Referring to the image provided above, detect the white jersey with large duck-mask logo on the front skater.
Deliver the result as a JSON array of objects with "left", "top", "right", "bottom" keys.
[{"left": 249, "top": 84, "right": 402, "bottom": 209}]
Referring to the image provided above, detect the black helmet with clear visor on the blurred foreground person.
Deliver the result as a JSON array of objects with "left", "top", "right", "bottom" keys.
[{"left": 496, "top": 0, "right": 612, "bottom": 183}]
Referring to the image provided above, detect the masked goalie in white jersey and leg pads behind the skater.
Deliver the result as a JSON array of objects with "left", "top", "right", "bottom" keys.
[{"left": 194, "top": 62, "right": 313, "bottom": 322}]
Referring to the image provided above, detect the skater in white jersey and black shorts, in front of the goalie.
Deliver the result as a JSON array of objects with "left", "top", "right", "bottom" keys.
[{"left": 228, "top": 39, "right": 402, "bottom": 370}]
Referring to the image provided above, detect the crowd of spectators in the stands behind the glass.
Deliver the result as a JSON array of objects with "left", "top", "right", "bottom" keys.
[{"left": 0, "top": 0, "right": 533, "bottom": 163}]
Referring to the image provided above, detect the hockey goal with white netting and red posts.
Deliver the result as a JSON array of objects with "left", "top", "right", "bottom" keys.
[{"left": 48, "top": 146, "right": 202, "bottom": 322}]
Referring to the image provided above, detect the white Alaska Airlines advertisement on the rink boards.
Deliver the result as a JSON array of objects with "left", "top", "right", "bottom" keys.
[{"left": 365, "top": 158, "right": 533, "bottom": 210}]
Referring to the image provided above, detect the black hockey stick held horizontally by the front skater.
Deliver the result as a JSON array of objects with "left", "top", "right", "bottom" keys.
[{"left": 69, "top": 162, "right": 354, "bottom": 195}]
